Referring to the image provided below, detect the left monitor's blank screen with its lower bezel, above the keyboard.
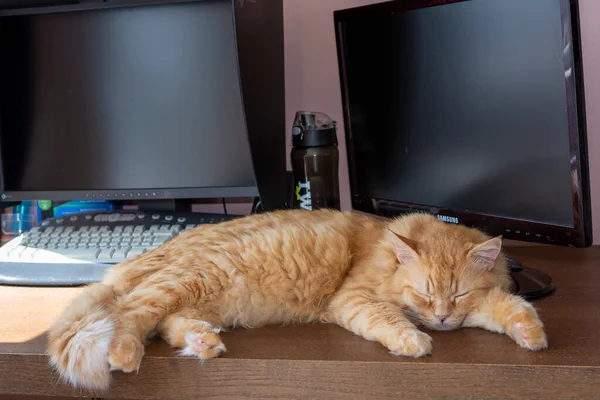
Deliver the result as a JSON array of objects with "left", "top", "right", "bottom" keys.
[{"left": 0, "top": 0, "right": 257, "bottom": 198}]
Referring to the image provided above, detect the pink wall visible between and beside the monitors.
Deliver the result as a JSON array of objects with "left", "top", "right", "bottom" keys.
[{"left": 284, "top": 0, "right": 600, "bottom": 244}]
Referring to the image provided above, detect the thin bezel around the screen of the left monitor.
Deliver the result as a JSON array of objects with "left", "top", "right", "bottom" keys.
[{"left": 0, "top": 0, "right": 260, "bottom": 201}]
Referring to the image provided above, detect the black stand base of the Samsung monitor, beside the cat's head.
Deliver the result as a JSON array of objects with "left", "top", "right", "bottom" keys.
[{"left": 506, "top": 257, "right": 555, "bottom": 300}]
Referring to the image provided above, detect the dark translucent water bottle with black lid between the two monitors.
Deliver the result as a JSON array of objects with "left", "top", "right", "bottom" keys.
[{"left": 291, "top": 111, "right": 340, "bottom": 210}]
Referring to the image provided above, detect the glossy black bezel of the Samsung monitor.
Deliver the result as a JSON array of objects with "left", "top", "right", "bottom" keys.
[{"left": 334, "top": 0, "right": 593, "bottom": 247}]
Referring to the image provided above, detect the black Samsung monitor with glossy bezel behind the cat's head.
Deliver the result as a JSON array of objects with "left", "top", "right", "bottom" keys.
[{"left": 334, "top": 0, "right": 592, "bottom": 298}]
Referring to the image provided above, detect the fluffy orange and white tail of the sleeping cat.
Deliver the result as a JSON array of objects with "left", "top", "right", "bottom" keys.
[{"left": 48, "top": 283, "right": 116, "bottom": 391}]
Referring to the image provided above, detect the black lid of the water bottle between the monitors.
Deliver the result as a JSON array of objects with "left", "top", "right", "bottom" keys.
[{"left": 292, "top": 111, "right": 337, "bottom": 148}]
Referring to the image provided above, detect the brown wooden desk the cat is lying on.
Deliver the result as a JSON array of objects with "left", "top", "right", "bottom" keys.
[{"left": 0, "top": 246, "right": 600, "bottom": 399}]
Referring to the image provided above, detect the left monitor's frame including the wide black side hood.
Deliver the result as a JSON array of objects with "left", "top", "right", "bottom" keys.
[{"left": 0, "top": 0, "right": 289, "bottom": 210}]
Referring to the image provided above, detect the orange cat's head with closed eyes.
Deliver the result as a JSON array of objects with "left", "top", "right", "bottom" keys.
[{"left": 390, "top": 228, "right": 506, "bottom": 330}]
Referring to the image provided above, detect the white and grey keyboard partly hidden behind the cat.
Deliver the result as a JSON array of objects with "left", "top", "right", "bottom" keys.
[{"left": 0, "top": 212, "right": 238, "bottom": 286}]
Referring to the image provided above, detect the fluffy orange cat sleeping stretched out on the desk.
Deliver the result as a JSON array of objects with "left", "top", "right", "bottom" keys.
[{"left": 48, "top": 210, "right": 547, "bottom": 390}]
